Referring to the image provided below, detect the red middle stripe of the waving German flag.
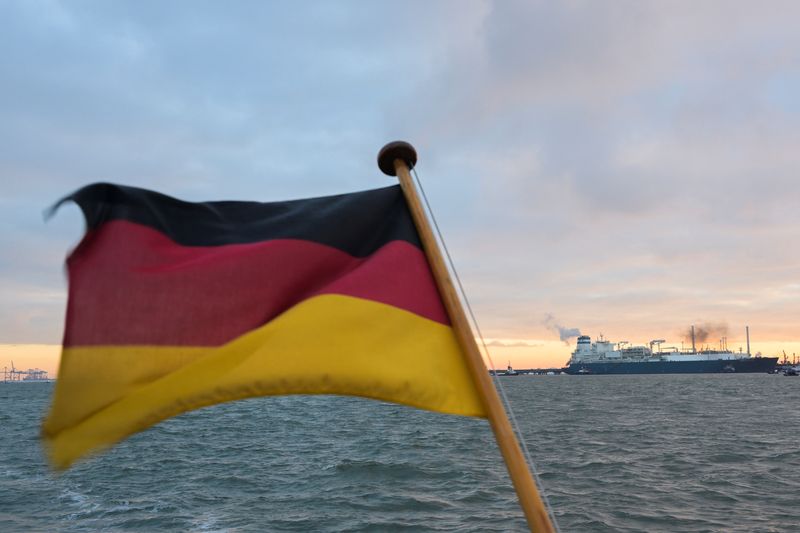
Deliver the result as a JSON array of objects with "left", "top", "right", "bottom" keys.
[{"left": 64, "top": 220, "right": 449, "bottom": 346}]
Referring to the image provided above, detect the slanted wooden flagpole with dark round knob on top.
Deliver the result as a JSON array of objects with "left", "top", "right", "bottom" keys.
[{"left": 378, "top": 141, "right": 555, "bottom": 533}]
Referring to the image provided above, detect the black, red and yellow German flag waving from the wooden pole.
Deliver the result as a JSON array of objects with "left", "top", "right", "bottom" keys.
[{"left": 42, "top": 183, "right": 486, "bottom": 468}]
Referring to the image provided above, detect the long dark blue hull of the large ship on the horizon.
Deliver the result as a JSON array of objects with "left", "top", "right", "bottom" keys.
[{"left": 566, "top": 357, "right": 778, "bottom": 375}]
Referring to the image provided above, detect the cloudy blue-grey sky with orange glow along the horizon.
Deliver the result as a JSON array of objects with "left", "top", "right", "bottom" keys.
[{"left": 0, "top": 0, "right": 800, "bottom": 373}]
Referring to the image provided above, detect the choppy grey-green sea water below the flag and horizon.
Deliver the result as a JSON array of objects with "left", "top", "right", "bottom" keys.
[{"left": 0, "top": 374, "right": 800, "bottom": 532}]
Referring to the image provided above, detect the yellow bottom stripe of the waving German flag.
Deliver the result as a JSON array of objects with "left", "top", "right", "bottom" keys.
[{"left": 44, "top": 295, "right": 486, "bottom": 468}]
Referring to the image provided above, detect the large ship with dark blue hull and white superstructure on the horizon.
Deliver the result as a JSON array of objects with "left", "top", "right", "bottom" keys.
[{"left": 566, "top": 326, "right": 778, "bottom": 375}]
